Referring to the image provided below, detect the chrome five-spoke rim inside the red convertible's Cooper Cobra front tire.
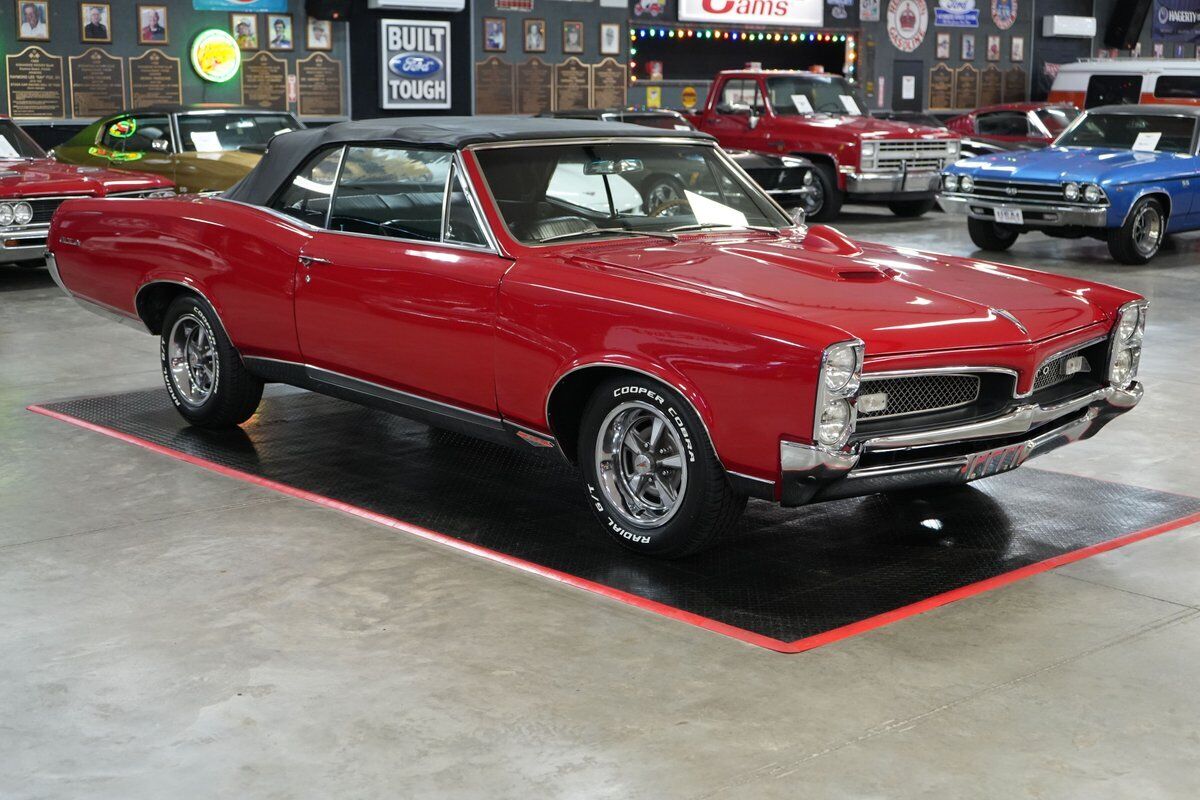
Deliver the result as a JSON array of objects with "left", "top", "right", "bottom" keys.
[{"left": 595, "top": 401, "right": 688, "bottom": 528}]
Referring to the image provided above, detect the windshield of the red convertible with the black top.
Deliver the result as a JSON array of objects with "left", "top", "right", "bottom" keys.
[{"left": 478, "top": 142, "right": 792, "bottom": 243}]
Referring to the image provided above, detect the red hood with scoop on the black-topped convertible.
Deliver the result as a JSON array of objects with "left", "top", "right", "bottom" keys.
[{"left": 576, "top": 231, "right": 1108, "bottom": 355}]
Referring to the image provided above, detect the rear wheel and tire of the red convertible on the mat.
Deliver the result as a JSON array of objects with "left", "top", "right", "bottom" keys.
[{"left": 158, "top": 294, "right": 263, "bottom": 428}]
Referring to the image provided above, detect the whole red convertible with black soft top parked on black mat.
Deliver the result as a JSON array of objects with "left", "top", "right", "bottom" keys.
[{"left": 49, "top": 118, "right": 1146, "bottom": 557}]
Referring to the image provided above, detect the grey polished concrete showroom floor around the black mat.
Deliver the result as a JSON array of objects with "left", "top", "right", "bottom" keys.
[{"left": 0, "top": 214, "right": 1200, "bottom": 800}]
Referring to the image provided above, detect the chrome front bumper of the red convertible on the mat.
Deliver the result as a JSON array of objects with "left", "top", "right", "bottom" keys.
[{"left": 779, "top": 383, "right": 1142, "bottom": 505}]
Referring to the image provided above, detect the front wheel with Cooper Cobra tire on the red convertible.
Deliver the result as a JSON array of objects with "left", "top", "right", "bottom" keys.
[{"left": 578, "top": 375, "right": 746, "bottom": 558}]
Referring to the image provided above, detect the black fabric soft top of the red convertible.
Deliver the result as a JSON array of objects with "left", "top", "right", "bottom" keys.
[{"left": 224, "top": 116, "right": 712, "bottom": 205}]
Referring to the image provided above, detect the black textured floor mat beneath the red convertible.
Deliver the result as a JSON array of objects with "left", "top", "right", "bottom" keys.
[{"left": 34, "top": 387, "right": 1200, "bottom": 650}]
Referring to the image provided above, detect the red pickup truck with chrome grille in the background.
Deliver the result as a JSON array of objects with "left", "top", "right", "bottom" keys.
[{"left": 691, "top": 70, "right": 960, "bottom": 222}]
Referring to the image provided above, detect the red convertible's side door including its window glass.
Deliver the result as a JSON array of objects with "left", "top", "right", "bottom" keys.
[{"left": 295, "top": 145, "right": 511, "bottom": 414}]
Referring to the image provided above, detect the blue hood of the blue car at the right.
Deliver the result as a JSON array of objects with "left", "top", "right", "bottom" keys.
[{"left": 950, "top": 148, "right": 1194, "bottom": 184}]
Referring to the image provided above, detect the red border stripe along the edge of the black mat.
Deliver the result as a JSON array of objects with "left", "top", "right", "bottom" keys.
[{"left": 26, "top": 405, "right": 1200, "bottom": 652}]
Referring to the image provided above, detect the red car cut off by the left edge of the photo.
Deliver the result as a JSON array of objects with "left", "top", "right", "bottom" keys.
[{"left": 0, "top": 118, "right": 175, "bottom": 264}]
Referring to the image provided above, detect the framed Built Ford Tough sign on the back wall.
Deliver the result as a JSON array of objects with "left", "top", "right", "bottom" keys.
[{"left": 379, "top": 19, "right": 450, "bottom": 109}]
